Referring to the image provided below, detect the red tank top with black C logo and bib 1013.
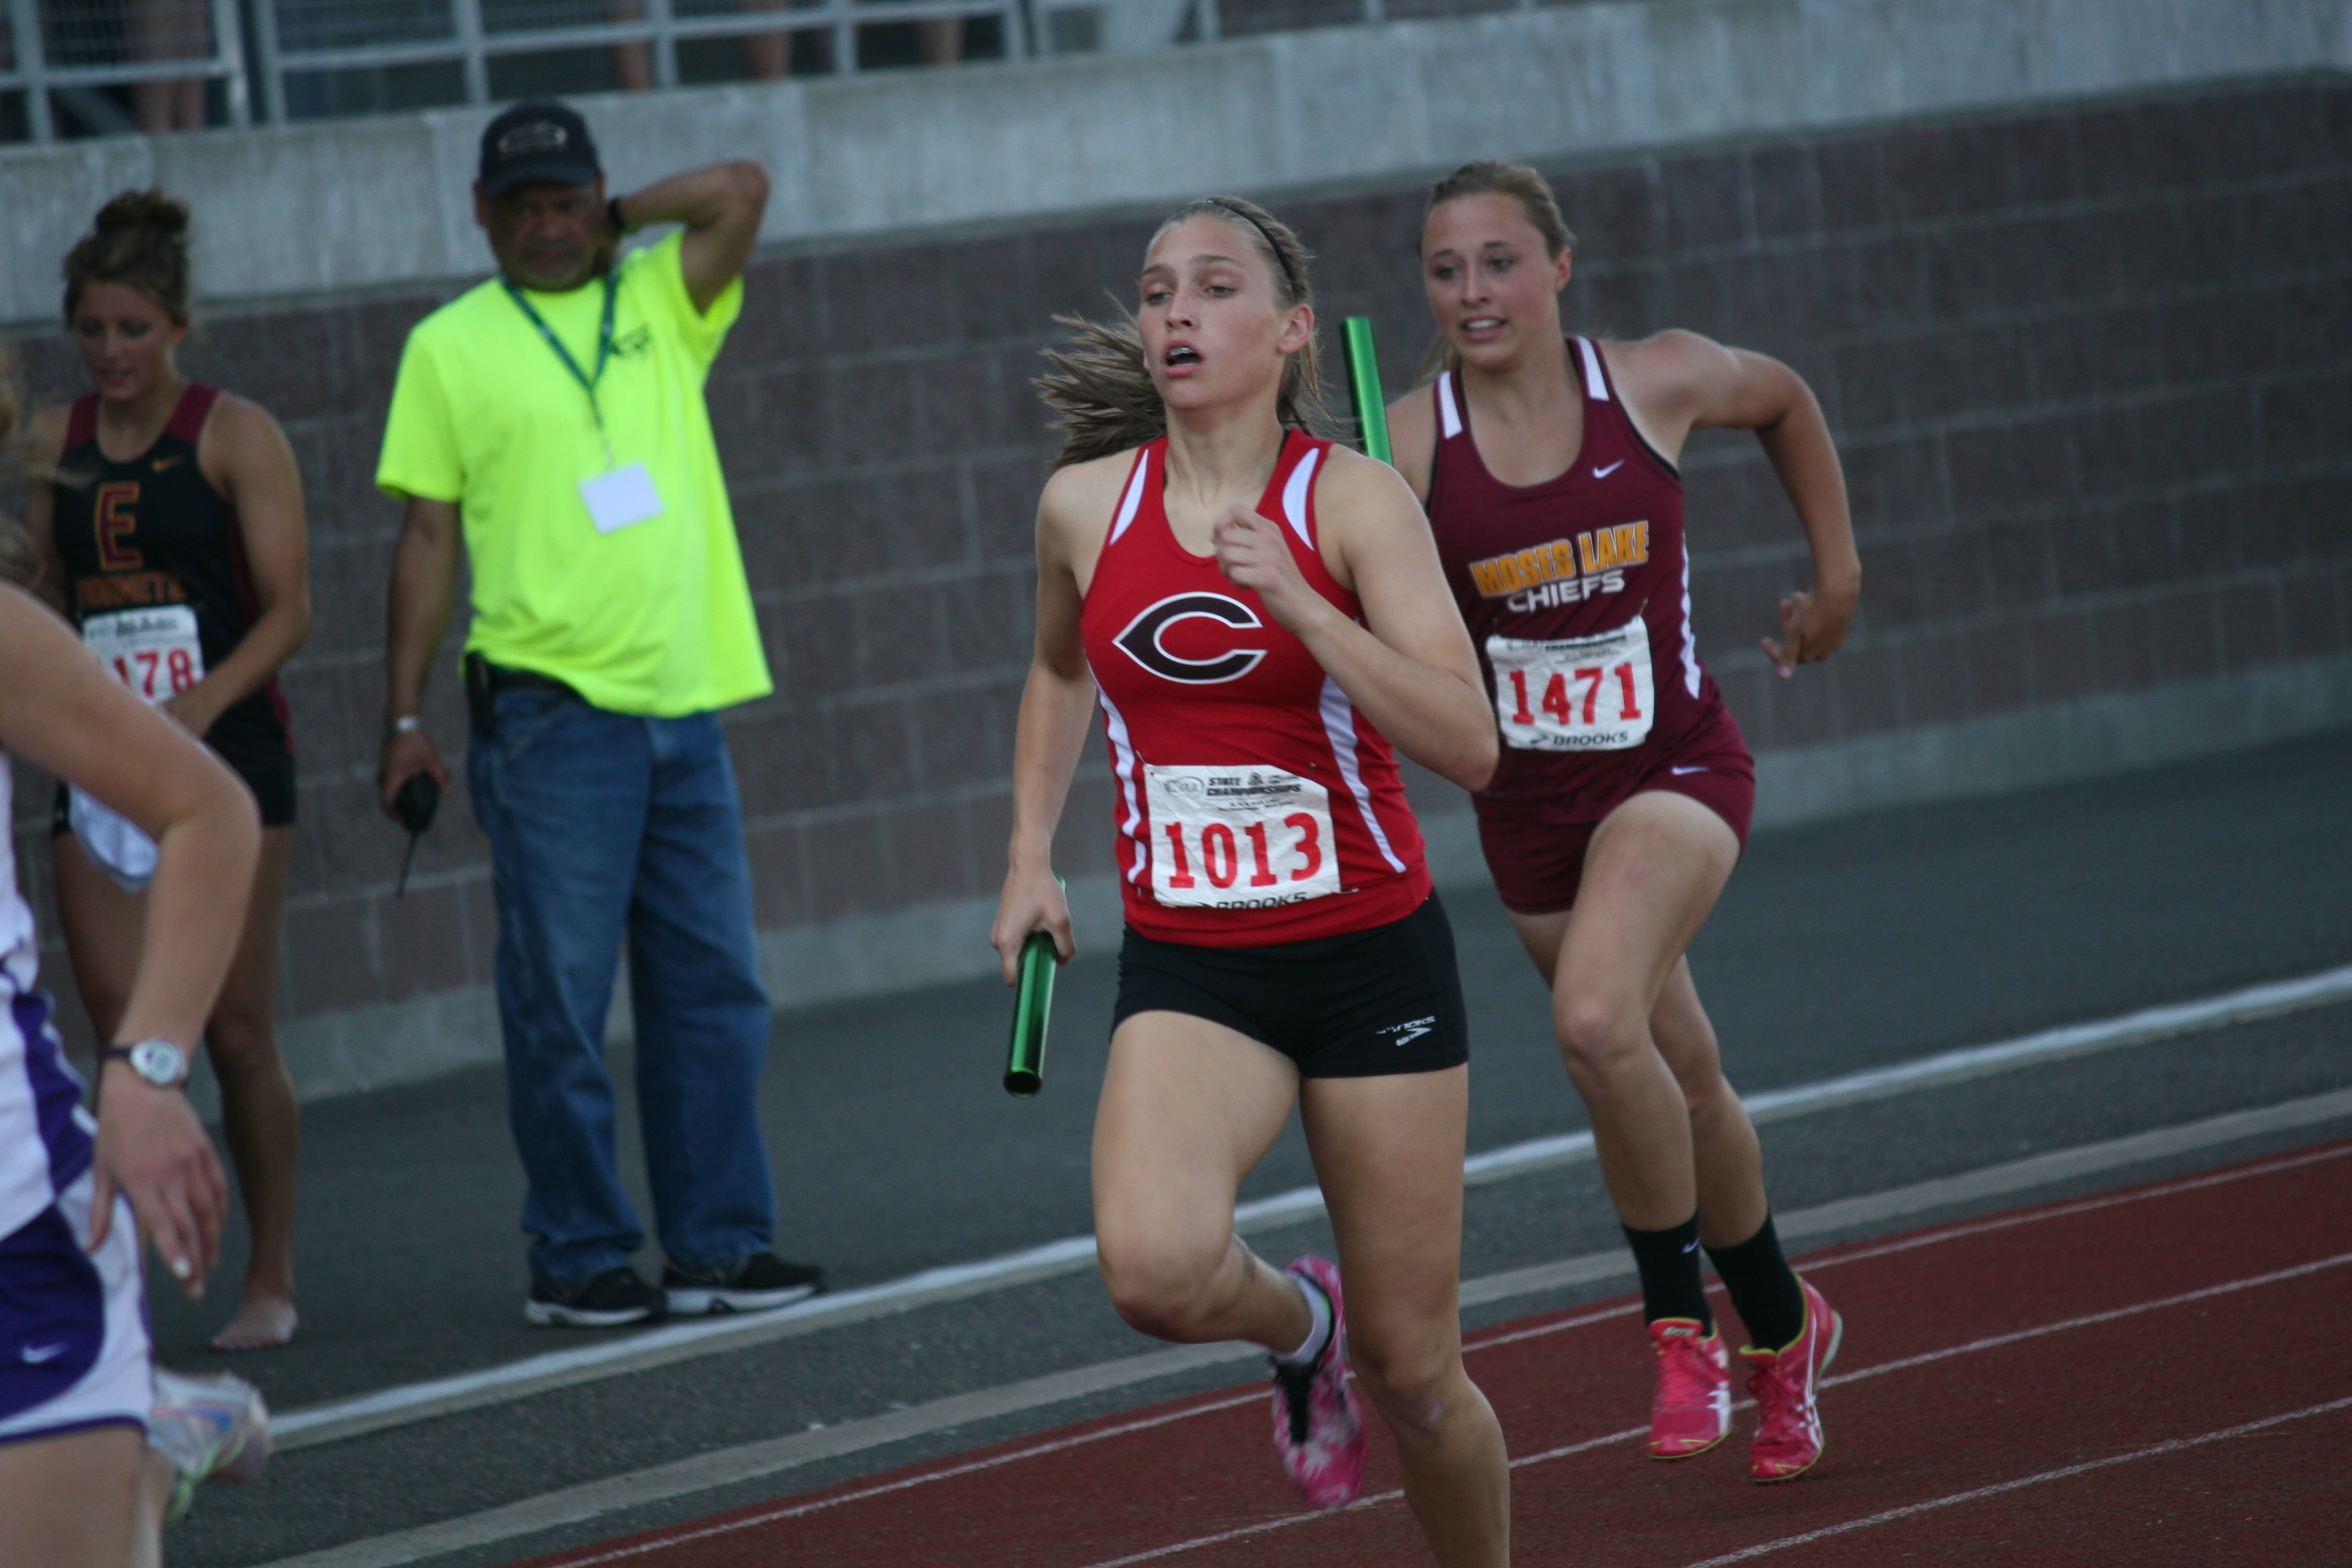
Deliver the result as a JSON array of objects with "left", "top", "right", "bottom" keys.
[{"left": 1079, "top": 430, "right": 1430, "bottom": 947}]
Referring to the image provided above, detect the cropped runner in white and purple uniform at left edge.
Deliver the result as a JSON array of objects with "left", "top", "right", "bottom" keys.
[{"left": 0, "top": 362, "right": 268, "bottom": 1568}]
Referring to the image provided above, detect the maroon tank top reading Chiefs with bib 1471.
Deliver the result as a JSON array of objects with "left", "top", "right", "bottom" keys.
[{"left": 1430, "top": 338, "right": 1728, "bottom": 823}]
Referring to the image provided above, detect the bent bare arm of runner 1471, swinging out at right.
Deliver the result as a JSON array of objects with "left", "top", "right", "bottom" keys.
[{"left": 1604, "top": 332, "right": 1863, "bottom": 677}]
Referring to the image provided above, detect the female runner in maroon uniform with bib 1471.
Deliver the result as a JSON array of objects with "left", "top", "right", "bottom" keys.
[{"left": 1390, "top": 162, "right": 1863, "bottom": 1481}]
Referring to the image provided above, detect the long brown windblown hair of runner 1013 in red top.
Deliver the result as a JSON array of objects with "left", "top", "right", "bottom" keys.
[{"left": 1030, "top": 195, "right": 1331, "bottom": 468}]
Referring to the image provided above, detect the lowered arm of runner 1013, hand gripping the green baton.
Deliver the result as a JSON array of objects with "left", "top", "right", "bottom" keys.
[{"left": 988, "top": 458, "right": 1110, "bottom": 985}]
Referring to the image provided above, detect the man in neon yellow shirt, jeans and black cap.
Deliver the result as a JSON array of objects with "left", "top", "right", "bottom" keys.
[{"left": 377, "top": 101, "right": 823, "bottom": 1328}]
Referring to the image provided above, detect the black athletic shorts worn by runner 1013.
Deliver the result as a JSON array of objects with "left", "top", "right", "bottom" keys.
[{"left": 1110, "top": 893, "right": 1470, "bottom": 1079}]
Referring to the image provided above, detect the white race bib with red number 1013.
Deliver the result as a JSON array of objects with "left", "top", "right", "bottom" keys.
[{"left": 1143, "top": 764, "right": 1338, "bottom": 910}]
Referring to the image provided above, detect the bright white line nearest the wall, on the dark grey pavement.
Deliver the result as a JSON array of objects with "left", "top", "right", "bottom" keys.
[{"left": 262, "top": 964, "right": 2352, "bottom": 1453}]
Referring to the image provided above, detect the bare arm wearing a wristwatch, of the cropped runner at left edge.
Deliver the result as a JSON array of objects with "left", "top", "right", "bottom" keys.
[{"left": 0, "top": 588, "right": 248, "bottom": 1295}]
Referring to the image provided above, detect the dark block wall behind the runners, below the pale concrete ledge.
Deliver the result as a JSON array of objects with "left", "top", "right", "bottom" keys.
[{"left": 19, "top": 78, "right": 2352, "bottom": 1053}]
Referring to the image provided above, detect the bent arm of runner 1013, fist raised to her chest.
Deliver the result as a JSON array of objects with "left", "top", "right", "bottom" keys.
[{"left": 1214, "top": 446, "right": 1501, "bottom": 790}]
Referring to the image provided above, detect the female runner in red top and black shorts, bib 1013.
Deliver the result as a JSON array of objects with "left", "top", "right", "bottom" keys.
[{"left": 993, "top": 197, "right": 1510, "bottom": 1565}]
